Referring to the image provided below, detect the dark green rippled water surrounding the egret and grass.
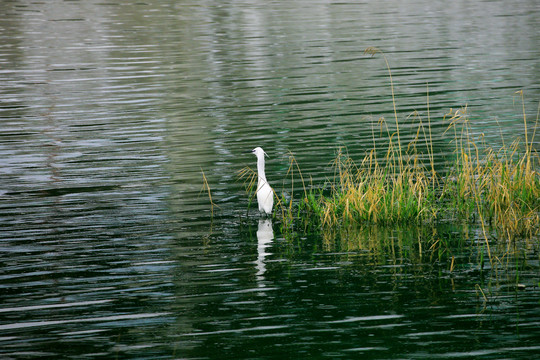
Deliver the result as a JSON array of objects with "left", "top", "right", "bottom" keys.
[{"left": 0, "top": 0, "right": 540, "bottom": 359}]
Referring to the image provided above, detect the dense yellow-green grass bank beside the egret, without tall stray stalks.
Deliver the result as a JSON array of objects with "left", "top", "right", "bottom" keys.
[{"left": 299, "top": 100, "right": 540, "bottom": 241}]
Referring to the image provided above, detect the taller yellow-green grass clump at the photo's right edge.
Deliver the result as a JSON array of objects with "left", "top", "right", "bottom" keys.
[{"left": 442, "top": 102, "right": 540, "bottom": 238}]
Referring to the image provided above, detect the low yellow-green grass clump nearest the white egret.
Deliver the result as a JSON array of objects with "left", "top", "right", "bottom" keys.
[{"left": 310, "top": 149, "right": 438, "bottom": 226}]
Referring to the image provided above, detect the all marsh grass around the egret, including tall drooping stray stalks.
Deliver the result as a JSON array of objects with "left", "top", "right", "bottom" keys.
[{"left": 212, "top": 48, "right": 540, "bottom": 262}]
